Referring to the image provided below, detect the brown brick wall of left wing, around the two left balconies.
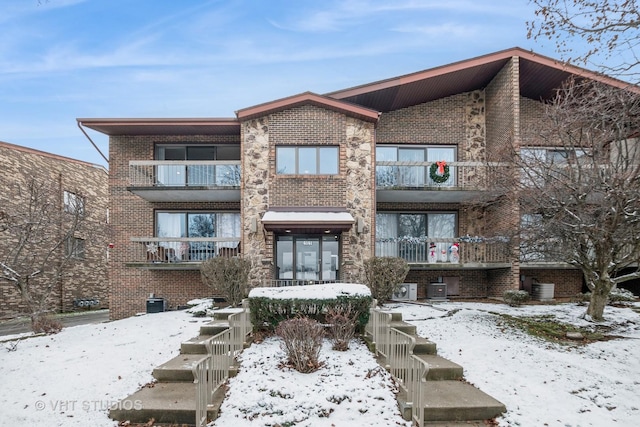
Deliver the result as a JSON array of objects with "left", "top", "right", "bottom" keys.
[{"left": 109, "top": 135, "right": 241, "bottom": 319}]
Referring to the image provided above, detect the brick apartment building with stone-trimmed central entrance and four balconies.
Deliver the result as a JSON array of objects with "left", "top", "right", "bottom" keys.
[{"left": 78, "top": 48, "right": 632, "bottom": 318}]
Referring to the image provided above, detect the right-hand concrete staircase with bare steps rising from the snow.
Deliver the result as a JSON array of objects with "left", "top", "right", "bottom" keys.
[{"left": 380, "top": 313, "right": 506, "bottom": 427}]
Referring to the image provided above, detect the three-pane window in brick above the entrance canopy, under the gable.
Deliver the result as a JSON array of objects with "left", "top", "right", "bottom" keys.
[{"left": 276, "top": 146, "right": 339, "bottom": 175}]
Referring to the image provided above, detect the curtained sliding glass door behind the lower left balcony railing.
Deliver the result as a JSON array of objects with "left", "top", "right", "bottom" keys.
[{"left": 156, "top": 211, "right": 241, "bottom": 261}]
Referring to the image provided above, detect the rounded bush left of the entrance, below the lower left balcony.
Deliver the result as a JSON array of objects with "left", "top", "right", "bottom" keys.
[{"left": 200, "top": 257, "right": 251, "bottom": 306}]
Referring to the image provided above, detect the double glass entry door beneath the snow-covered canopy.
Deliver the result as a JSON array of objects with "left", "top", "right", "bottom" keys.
[{"left": 276, "top": 235, "right": 340, "bottom": 281}]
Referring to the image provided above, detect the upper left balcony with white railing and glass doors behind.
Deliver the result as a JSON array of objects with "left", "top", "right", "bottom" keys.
[{"left": 127, "top": 160, "right": 241, "bottom": 202}]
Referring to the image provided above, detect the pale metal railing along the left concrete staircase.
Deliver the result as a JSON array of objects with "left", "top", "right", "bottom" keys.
[{"left": 192, "top": 307, "right": 251, "bottom": 427}]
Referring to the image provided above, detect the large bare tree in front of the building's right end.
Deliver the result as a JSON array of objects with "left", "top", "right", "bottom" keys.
[{"left": 502, "top": 80, "right": 640, "bottom": 320}]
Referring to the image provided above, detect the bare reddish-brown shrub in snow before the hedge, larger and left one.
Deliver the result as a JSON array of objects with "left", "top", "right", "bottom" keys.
[{"left": 276, "top": 317, "right": 324, "bottom": 373}]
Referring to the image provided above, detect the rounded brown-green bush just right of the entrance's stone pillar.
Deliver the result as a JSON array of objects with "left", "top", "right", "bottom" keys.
[{"left": 364, "top": 257, "right": 409, "bottom": 302}]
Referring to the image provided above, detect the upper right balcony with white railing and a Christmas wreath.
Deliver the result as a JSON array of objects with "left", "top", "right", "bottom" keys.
[{"left": 376, "top": 161, "right": 499, "bottom": 203}]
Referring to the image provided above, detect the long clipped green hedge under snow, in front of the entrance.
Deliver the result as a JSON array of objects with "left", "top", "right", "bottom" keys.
[{"left": 249, "top": 295, "right": 372, "bottom": 332}]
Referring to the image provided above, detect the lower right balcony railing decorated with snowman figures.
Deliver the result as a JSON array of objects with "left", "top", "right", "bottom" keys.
[{"left": 376, "top": 237, "right": 511, "bottom": 270}]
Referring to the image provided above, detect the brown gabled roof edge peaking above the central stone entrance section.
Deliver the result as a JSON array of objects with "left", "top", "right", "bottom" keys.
[{"left": 236, "top": 92, "right": 380, "bottom": 123}]
